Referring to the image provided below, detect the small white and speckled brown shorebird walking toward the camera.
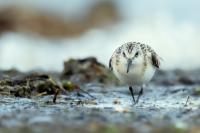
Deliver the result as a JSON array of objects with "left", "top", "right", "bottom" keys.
[{"left": 109, "top": 42, "right": 161, "bottom": 104}]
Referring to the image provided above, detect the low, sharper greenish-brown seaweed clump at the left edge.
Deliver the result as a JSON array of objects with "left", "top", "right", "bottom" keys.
[{"left": 0, "top": 74, "right": 60, "bottom": 98}]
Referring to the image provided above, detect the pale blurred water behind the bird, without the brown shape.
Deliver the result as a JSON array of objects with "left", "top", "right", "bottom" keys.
[{"left": 0, "top": 0, "right": 200, "bottom": 71}]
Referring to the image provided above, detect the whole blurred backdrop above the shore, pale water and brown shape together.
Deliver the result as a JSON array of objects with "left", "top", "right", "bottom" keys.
[{"left": 0, "top": 0, "right": 200, "bottom": 71}]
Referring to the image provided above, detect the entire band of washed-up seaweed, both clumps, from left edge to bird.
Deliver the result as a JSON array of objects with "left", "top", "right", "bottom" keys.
[{"left": 0, "top": 57, "right": 118, "bottom": 102}]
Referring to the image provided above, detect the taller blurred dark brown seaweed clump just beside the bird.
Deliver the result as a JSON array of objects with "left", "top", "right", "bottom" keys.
[{"left": 62, "top": 57, "right": 119, "bottom": 84}]
